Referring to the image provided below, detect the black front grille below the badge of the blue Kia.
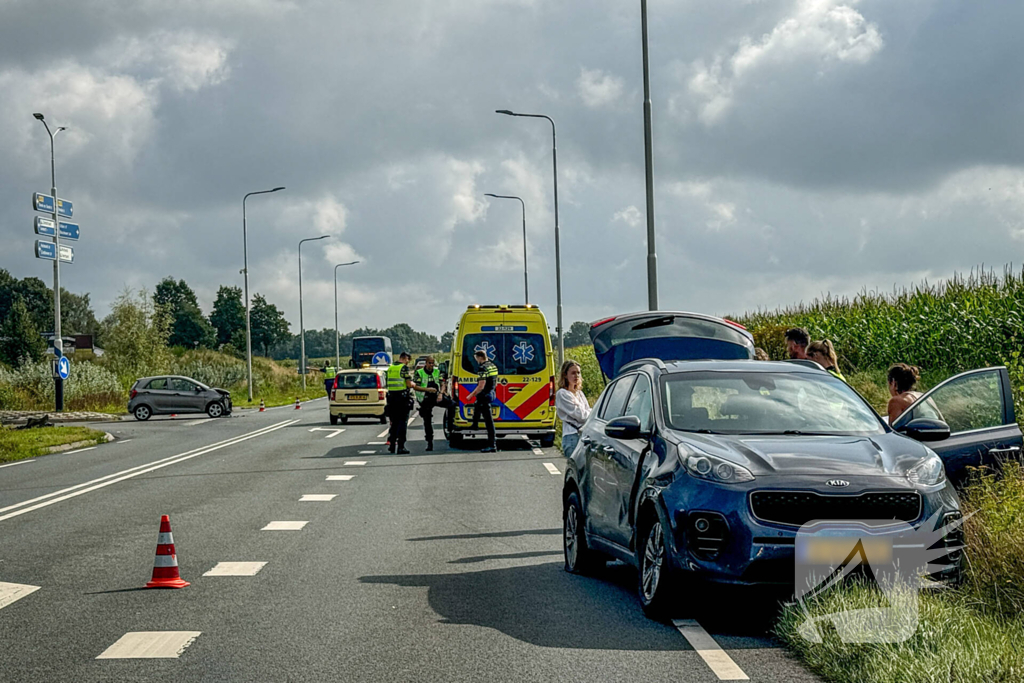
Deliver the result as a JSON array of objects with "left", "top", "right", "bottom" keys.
[{"left": 751, "top": 490, "right": 922, "bottom": 526}]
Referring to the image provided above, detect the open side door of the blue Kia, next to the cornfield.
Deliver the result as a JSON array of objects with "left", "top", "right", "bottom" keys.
[{"left": 892, "top": 367, "right": 1024, "bottom": 483}]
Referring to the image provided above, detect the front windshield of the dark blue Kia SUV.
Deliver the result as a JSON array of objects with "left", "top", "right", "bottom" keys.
[{"left": 662, "top": 372, "right": 885, "bottom": 435}]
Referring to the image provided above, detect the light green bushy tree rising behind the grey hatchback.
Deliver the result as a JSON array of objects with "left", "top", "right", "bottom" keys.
[{"left": 102, "top": 290, "right": 170, "bottom": 387}]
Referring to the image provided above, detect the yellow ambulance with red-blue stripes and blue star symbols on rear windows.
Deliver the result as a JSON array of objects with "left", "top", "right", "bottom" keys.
[{"left": 443, "top": 304, "right": 558, "bottom": 447}]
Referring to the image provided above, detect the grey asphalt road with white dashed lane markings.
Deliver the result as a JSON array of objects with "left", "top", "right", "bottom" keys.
[{"left": 0, "top": 400, "right": 817, "bottom": 683}]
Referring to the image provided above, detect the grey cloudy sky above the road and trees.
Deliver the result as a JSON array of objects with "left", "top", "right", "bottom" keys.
[{"left": 0, "top": 0, "right": 1024, "bottom": 334}]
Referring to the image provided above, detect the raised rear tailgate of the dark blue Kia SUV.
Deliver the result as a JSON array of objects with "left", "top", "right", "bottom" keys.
[{"left": 590, "top": 310, "right": 754, "bottom": 381}]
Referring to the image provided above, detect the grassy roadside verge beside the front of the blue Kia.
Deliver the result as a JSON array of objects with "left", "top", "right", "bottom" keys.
[{"left": 776, "top": 463, "right": 1024, "bottom": 683}]
